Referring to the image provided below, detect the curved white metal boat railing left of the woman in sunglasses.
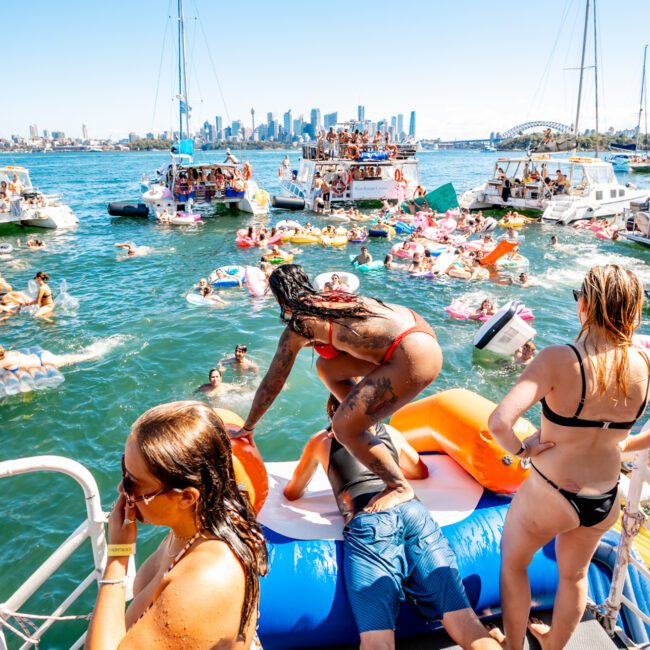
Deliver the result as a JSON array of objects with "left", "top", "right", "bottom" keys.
[{"left": 0, "top": 456, "right": 106, "bottom": 650}]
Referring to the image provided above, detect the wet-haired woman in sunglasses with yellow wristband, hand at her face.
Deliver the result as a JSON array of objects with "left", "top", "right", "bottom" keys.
[{"left": 86, "top": 401, "right": 267, "bottom": 650}]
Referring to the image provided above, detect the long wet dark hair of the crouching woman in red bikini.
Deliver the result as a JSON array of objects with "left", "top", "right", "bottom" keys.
[{"left": 269, "top": 264, "right": 373, "bottom": 339}]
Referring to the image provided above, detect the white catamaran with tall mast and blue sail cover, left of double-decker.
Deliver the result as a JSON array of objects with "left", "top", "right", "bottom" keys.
[{"left": 137, "top": 0, "right": 269, "bottom": 218}]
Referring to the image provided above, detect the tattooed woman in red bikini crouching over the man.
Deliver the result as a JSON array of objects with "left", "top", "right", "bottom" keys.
[{"left": 233, "top": 264, "right": 442, "bottom": 512}]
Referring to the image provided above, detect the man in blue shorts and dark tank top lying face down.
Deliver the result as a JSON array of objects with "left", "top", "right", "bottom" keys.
[{"left": 284, "top": 394, "right": 501, "bottom": 650}]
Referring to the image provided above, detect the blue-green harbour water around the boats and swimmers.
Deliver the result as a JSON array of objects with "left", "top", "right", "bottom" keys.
[{"left": 0, "top": 151, "right": 650, "bottom": 648}]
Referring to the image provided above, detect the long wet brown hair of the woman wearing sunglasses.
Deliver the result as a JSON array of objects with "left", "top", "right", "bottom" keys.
[{"left": 131, "top": 400, "right": 268, "bottom": 637}]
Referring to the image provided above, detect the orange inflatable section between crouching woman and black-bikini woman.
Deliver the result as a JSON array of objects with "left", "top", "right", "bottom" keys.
[{"left": 390, "top": 388, "right": 536, "bottom": 494}]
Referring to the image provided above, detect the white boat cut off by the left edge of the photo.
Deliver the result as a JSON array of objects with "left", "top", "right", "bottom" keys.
[{"left": 0, "top": 165, "right": 79, "bottom": 229}]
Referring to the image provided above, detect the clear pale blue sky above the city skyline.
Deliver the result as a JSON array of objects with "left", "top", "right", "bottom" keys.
[{"left": 5, "top": 0, "right": 650, "bottom": 138}]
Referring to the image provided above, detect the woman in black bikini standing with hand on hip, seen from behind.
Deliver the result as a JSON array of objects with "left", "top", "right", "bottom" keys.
[{"left": 489, "top": 265, "right": 650, "bottom": 650}]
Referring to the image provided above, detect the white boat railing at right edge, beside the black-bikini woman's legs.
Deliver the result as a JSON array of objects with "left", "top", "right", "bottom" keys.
[{"left": 597, "top": 450, "right": 650, "bottom": 636}]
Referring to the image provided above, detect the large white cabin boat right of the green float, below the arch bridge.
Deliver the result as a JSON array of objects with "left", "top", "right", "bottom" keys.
[{"left": 460, "top": 154, "right": 650, "bottom": 224}]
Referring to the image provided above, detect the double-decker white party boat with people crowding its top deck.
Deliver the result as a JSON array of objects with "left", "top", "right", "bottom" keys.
[{"left": 274, "top": 137, "right": 419, "bottom": 207}]
